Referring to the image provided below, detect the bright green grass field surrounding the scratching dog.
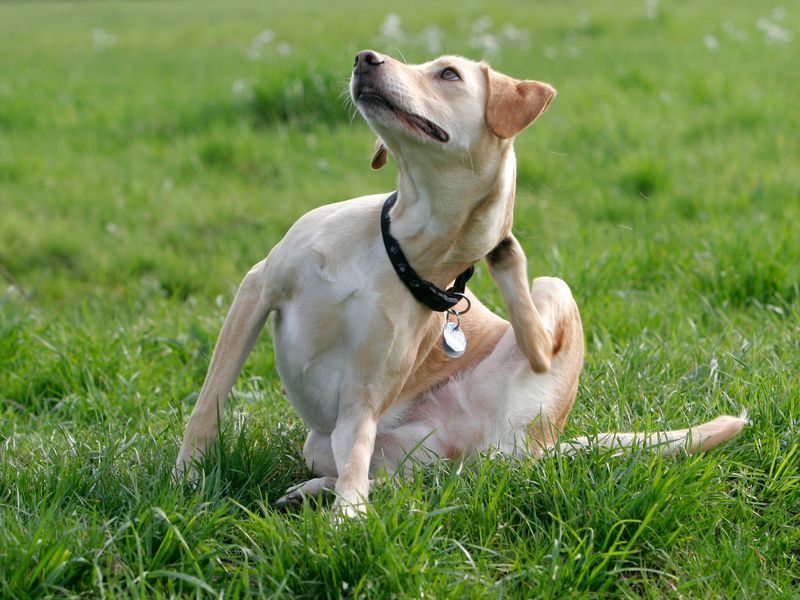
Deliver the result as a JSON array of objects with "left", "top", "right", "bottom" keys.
[{"left": 0, "top": 0, "right": 800, "bottom": 598}]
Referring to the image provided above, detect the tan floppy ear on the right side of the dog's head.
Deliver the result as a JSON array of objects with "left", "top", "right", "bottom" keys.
[{"left": 483, "top": 65, "right": 556, "bottom": 138}]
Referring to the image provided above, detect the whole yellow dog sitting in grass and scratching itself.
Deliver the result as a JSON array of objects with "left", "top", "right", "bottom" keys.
[{"left": 175, "top": 51, "right": 744, "bottom": 514}]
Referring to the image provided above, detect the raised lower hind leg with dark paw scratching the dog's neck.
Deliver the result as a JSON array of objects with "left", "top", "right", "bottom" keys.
[{"left": 486, "top": 234, "right": 553, "bottom": 373}]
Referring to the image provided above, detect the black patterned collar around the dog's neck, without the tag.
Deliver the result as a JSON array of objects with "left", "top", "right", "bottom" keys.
[{"left": 381, "top": 192, "right": 475, "bottom": 312}]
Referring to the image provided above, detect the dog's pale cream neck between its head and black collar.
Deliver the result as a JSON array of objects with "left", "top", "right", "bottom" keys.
[{"left": 391, "top": 143, "right": 516, "bottom": 288}]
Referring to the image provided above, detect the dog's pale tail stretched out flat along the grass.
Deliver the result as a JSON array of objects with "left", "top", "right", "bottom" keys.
[{"left": 555, "top": 413, "right": 748, "bottom": 455}]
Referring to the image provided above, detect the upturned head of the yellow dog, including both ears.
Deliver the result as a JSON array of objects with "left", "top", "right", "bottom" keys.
[{"left": 350, "top": 50, "right": 556, "bottom": 168}]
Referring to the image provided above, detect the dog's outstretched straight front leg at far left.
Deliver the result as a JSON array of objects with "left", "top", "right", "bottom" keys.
[{"left": 174, "top": 261, "right": 270, "bottom": 479}]
